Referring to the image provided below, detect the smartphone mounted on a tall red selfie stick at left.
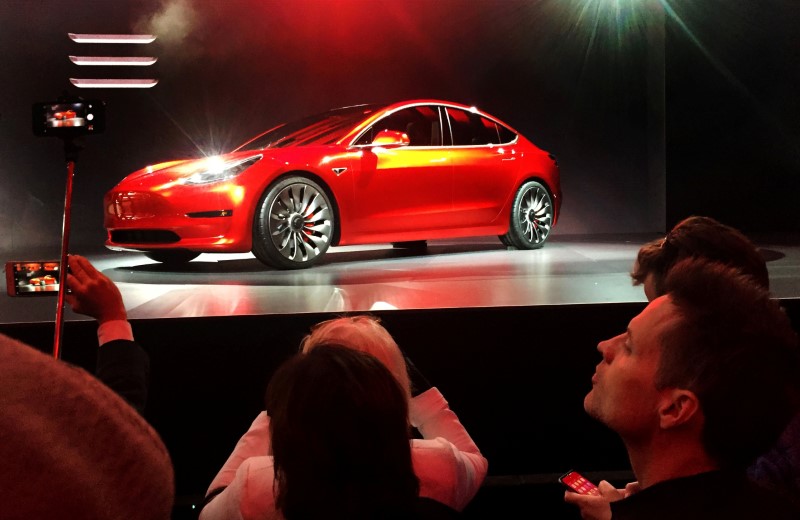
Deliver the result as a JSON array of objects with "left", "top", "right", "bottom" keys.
[{"left": 28, "top": 92, "right": 105, "bottom": 359}]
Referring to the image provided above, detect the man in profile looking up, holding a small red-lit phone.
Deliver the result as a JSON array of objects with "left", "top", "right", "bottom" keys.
[{"left": 565, "top": 258, "right": 800, "bottom": 520}]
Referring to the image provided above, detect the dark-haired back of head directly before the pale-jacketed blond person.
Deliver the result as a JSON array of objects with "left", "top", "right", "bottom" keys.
[{"left": 266, "top": 344, "right": 419, "bottom": 520}]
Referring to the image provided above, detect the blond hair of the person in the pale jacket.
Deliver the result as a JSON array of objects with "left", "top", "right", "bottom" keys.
[{"left": 300, "top": 314, "right": 411, "bottom": 395}]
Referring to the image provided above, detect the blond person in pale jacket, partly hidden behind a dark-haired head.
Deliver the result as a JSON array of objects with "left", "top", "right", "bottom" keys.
[{"left": 200, "top": 315, "right": 489, "bottom": 520}]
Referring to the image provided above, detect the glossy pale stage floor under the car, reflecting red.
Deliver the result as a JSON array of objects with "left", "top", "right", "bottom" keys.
[{"left": 0, "top": 235, "right": 800, "bottom": 323}]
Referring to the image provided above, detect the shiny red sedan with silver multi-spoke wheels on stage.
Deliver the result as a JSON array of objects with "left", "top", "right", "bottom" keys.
[{"left": 104, "top": 100, "right": 561, "bottom": 269}]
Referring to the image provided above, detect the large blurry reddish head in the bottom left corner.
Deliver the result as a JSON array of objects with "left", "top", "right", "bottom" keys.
[{"left": 0, "top": 335, "right": 175, "bottom": 520}]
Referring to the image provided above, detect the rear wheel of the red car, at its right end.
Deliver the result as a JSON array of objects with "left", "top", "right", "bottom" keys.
[{"left": 500, "top": 181, "right": 554, "bottom": 249}]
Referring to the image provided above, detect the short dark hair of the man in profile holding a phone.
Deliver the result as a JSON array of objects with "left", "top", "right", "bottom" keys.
[{"left": 656, "top": 259, "right": 800, "bottom": 468}]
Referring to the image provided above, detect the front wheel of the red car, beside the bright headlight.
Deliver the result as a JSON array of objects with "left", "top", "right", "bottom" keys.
[{"left": 253, "top": 176, "right": 335, "bottom": 269}]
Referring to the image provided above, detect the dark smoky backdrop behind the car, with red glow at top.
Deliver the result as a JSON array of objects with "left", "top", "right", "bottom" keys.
[{"left": 0, "top": 0, "right": 800, "bottom": 255}]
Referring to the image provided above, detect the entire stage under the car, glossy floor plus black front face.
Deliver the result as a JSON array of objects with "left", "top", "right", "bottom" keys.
[{"left": 0, "top": 235, "right": 800, "bottom": 519}]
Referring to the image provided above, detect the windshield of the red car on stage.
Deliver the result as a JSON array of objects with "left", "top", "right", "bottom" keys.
[{"left": 235, "top": 105, "right": 382, "bottom": 152}]
